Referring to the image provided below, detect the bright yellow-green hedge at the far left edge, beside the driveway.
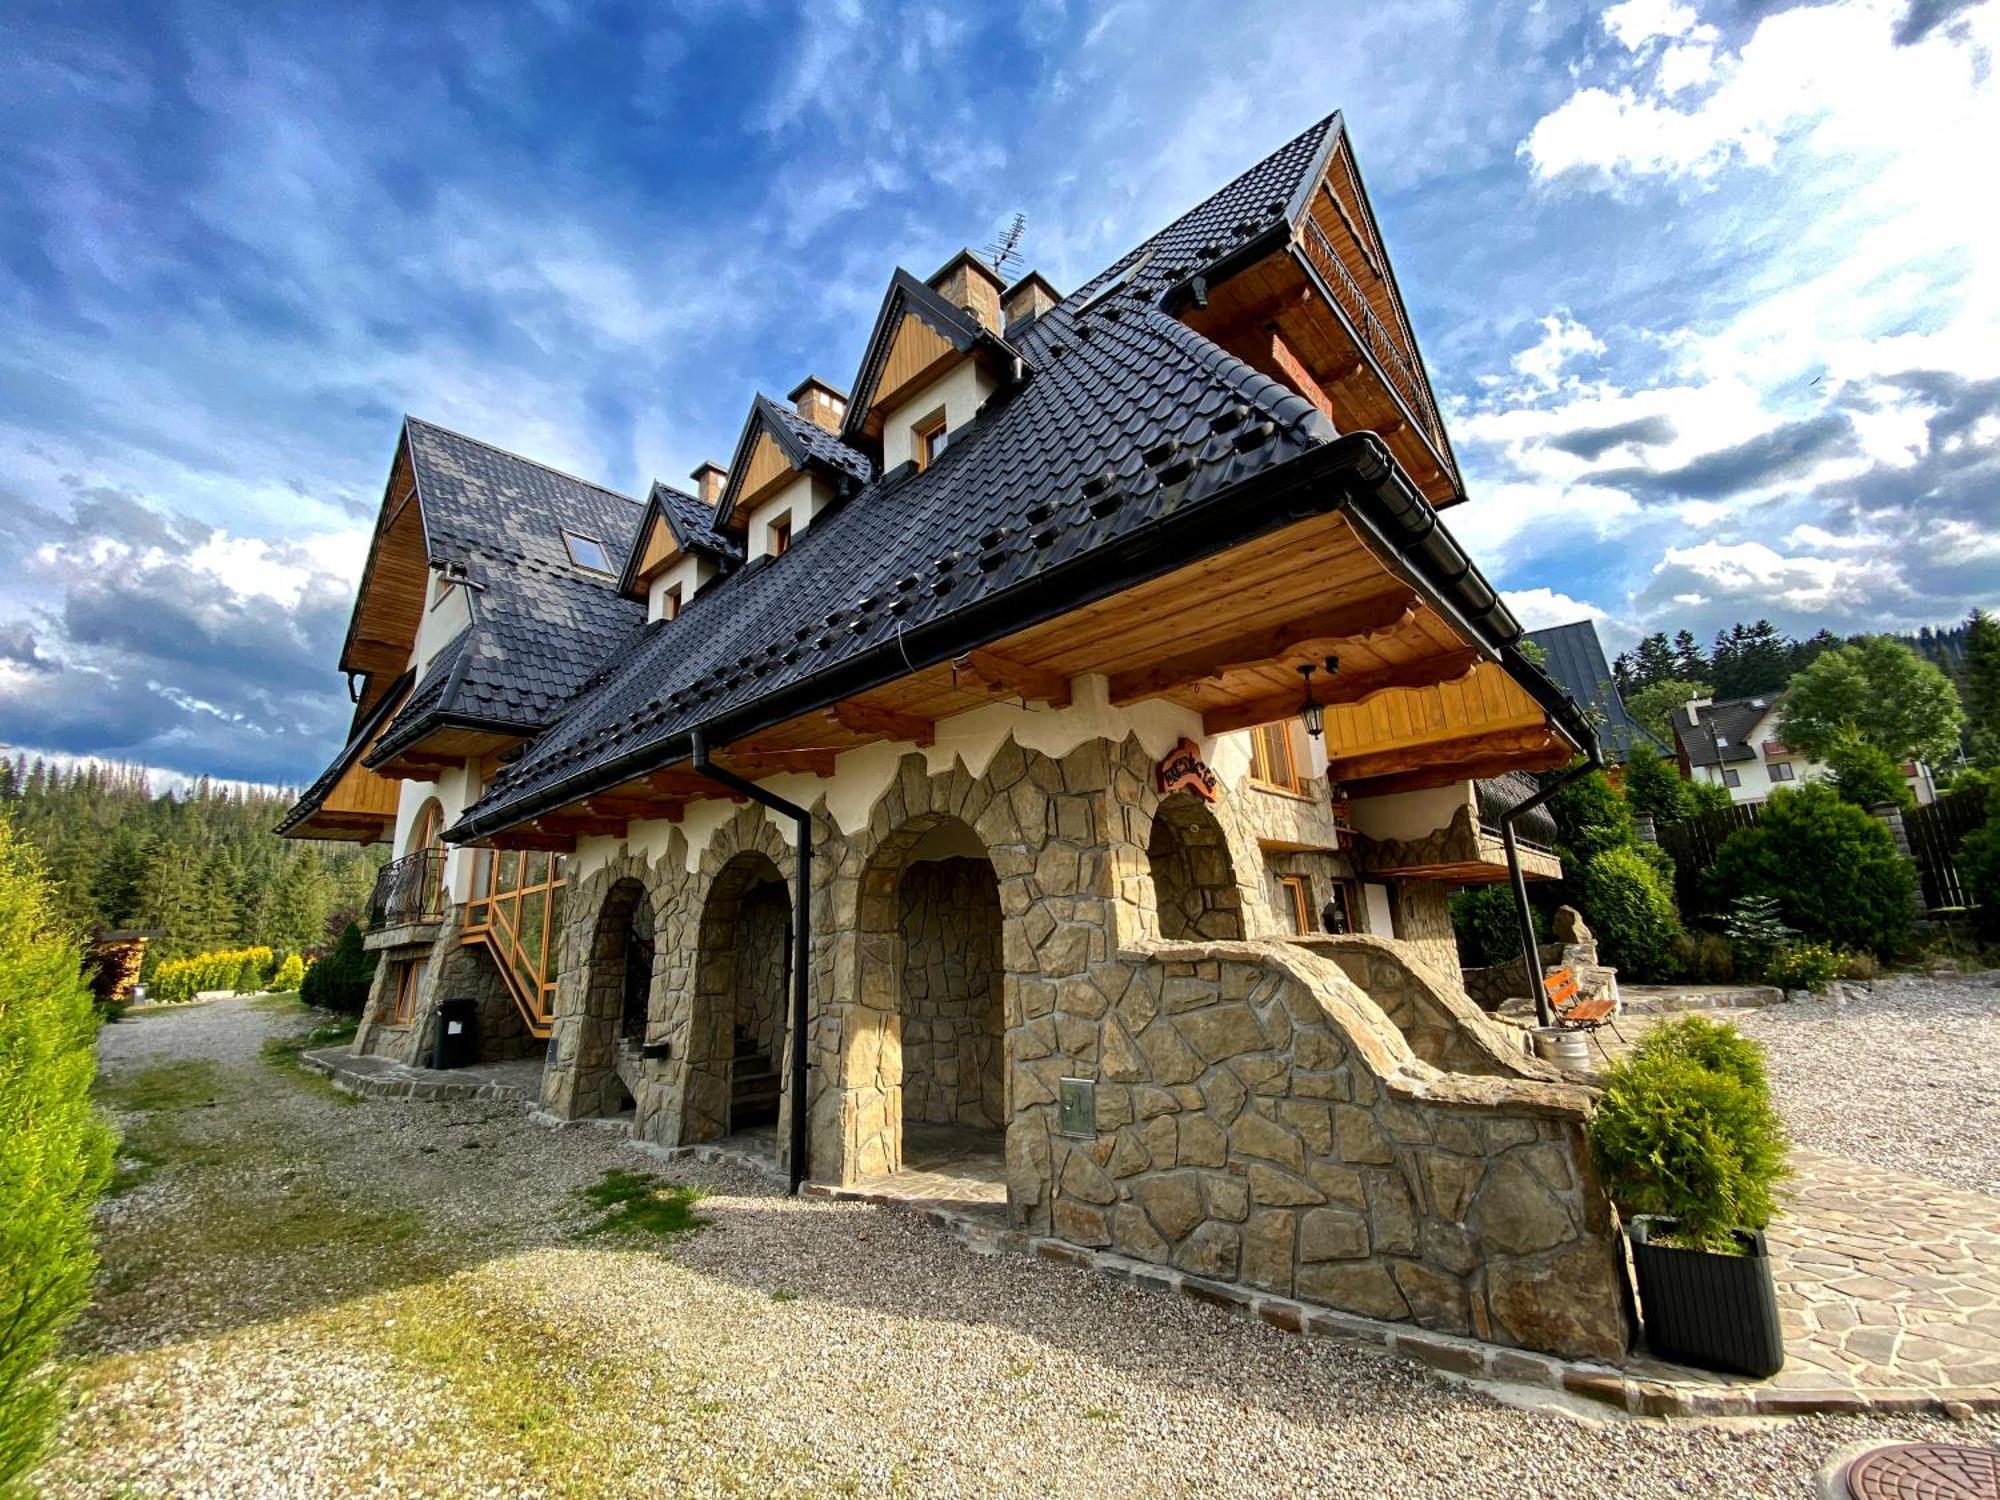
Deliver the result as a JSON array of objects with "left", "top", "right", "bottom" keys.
[{"left": 0, "top": 818, "right": 112, "bottom": 1494}]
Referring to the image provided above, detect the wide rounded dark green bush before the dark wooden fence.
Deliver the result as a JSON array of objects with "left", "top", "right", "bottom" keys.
[{"left": 1708, "top": 784, "right": 1916, "bottom": 954}]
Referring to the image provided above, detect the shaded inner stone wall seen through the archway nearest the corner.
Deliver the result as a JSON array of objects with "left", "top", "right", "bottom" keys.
[{"left": 900, "top": 858, "right": 1006, "bottom": 1130}]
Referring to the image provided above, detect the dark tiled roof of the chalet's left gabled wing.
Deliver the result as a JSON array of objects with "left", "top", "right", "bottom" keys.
[{"left": 370, "top": 418, "right": 646, "bottom": 760}]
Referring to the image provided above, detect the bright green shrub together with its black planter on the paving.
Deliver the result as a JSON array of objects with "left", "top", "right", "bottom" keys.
[{"left": 1590, "top": 1016, "right": 1786, "bottom": 1376}]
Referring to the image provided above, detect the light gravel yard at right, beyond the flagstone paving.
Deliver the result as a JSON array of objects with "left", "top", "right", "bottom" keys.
[{"left": 1728, "top": 972, "right": 2000, "bottom": 1196}]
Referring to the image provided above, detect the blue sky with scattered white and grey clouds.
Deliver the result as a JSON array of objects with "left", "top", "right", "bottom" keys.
[{"left": 0, "top": 0, "right": 2000, "bottom": 782}]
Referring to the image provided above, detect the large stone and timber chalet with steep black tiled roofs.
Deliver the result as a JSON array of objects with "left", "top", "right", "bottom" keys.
[{"left": 284, "top": 116, "right": 1626, "bottom": 1356}]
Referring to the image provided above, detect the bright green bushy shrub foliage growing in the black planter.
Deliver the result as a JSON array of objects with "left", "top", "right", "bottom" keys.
[{"left": 1590, "top": 1016, "right": 1786, "bottom": 1252}]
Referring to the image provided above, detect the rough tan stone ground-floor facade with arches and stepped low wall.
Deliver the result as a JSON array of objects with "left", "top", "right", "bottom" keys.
[{"left": 364, "top": 734, "right": 1624, "bottom": 1356}]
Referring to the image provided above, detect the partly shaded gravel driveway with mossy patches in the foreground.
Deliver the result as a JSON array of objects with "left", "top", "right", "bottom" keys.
[{"left": 42, "top": 1002, "right": 2000, "bottom": 1500}]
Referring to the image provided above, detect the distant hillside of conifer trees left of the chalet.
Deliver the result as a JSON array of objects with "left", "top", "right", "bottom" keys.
[{"left": 0, "top": 758, "right": 384, "bottom": 968}]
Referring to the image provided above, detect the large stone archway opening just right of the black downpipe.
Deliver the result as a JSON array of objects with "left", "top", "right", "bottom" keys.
[{"left": 850, "top": 816, "right": 1010, "bottom": 1182}]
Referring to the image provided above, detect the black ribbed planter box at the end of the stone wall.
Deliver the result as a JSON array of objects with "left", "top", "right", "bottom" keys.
[{"left": 1628, "top": 1218, "right": 1784, "bottom": 1378}]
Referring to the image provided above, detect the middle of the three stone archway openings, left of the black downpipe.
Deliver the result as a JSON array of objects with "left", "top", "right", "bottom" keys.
[{"left": 682, "top": 850, "right": 792, "bottom": 1142}]
